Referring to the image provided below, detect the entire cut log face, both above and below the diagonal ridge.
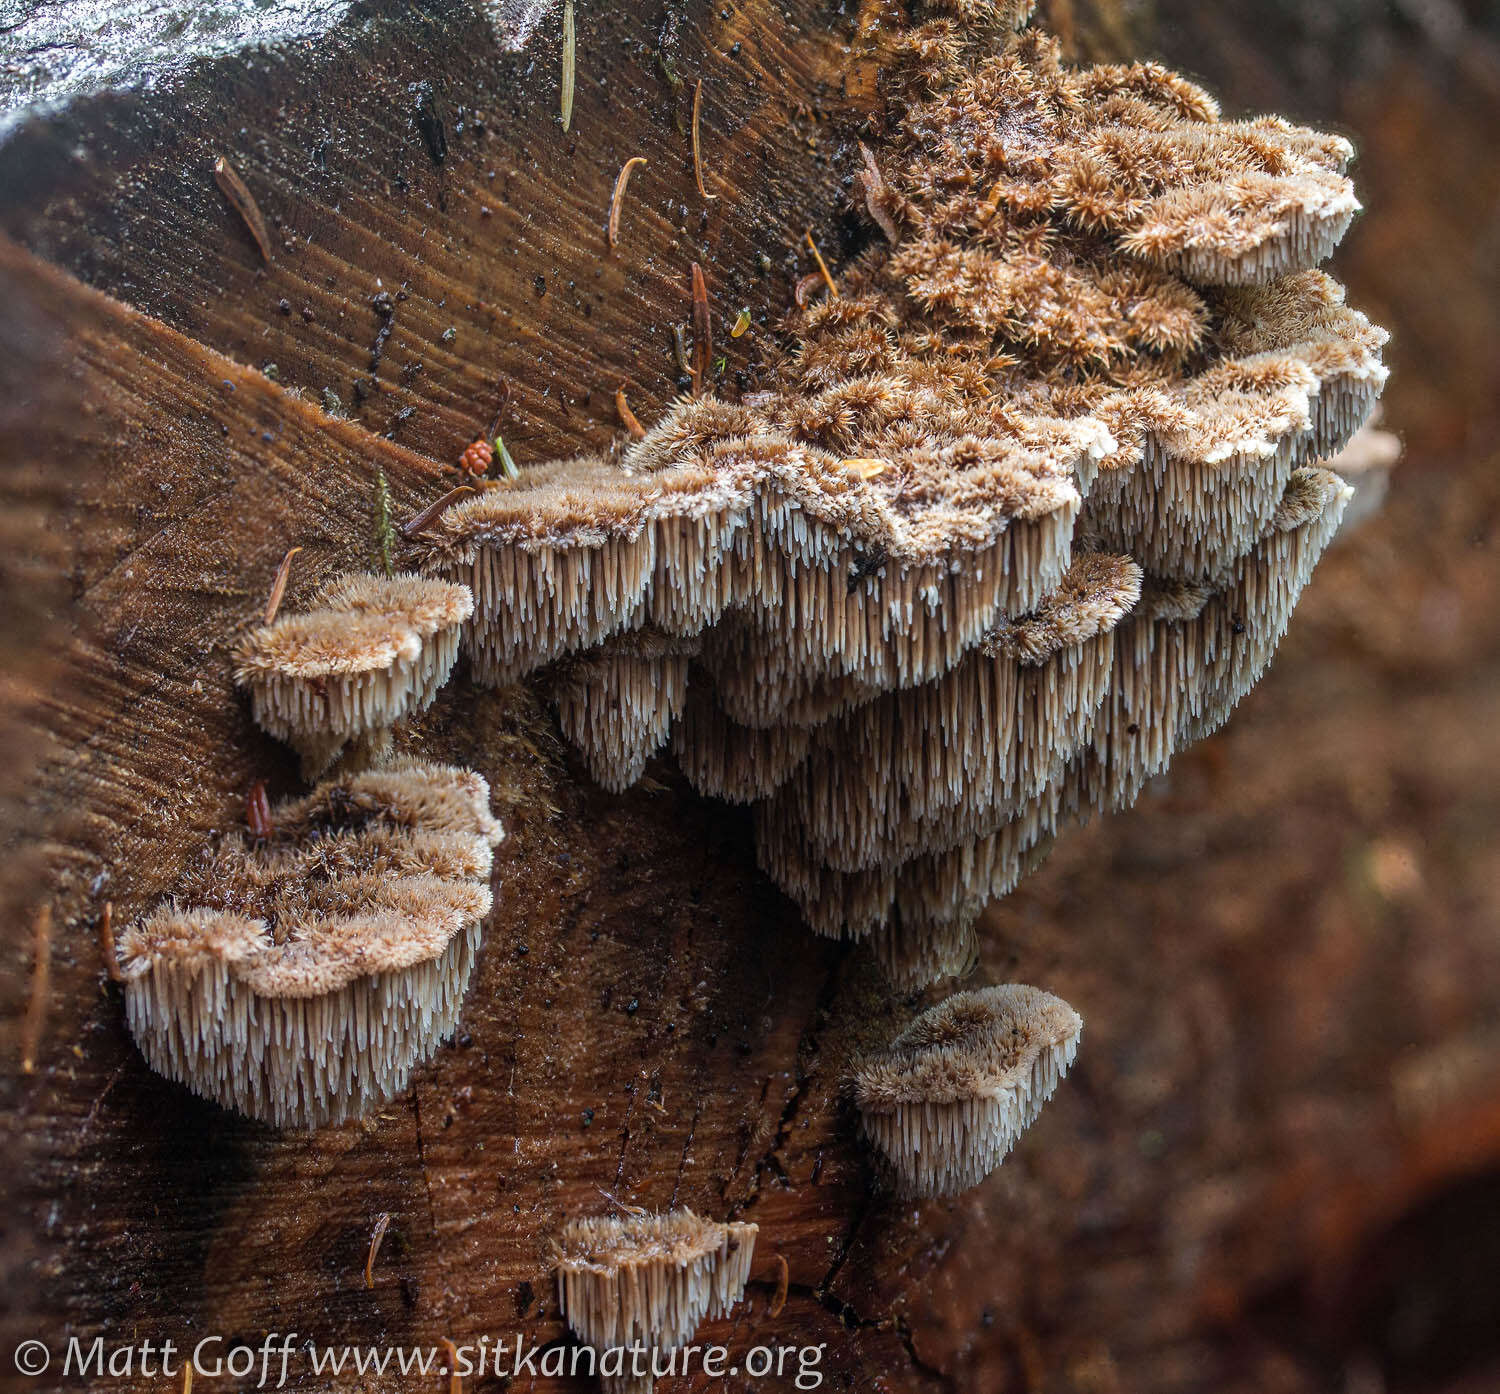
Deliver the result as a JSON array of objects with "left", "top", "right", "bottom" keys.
[{"left": 0, "top": 3, "right": 923, "bottom": 1388}]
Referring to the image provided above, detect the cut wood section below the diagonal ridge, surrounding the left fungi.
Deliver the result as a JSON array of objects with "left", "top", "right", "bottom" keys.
[{"left": 0, "top": 217, "right": 896, "bottom": 1392}]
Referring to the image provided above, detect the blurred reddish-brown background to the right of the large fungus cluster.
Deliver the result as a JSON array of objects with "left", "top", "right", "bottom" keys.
[{"left": 933, "top": 0, "right": 1500, "bottom": 1394}]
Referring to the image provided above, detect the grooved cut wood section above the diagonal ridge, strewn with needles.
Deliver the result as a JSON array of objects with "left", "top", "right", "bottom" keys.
[{"left": 0, "top": 0, "right": 879, "bottom": 461}]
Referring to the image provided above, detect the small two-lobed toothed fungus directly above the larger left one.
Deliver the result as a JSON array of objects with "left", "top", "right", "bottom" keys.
[{"left": 236, "top": 572, "right": 474, "bottom": 779}]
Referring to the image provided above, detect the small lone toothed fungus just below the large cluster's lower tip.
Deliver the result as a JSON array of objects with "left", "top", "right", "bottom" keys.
[{"left": 854, "top": 983, "right": 1083, "bottom": 1197}]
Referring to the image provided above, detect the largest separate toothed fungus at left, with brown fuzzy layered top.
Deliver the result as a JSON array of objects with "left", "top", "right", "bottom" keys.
[{"left": 119, "top": 759, "right": 503, "bottom": 1128}]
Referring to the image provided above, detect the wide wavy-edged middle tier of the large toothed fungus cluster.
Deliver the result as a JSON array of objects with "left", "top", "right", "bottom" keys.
[{"left": 422, "top": 399, "right": 1110, "bottom": 696}]
